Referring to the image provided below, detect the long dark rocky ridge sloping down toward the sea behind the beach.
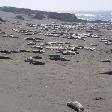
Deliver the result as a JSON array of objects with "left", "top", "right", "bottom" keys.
[{"left": 0, "top": 7, "right": 79, "bottom": 22}]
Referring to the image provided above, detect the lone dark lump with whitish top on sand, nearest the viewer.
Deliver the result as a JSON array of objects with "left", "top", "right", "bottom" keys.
[{"left": 67, "top": 101, "right": 84, "bottom": 112}]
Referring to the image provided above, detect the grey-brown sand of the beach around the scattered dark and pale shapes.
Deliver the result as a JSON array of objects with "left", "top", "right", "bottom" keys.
[{"left": 0, "top": 11, "right": 112, "bottom": 112}]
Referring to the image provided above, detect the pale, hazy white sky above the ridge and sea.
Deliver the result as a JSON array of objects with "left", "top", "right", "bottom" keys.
[{"left": 0, "top": 0, "right": 112, "bottom": 12}]
